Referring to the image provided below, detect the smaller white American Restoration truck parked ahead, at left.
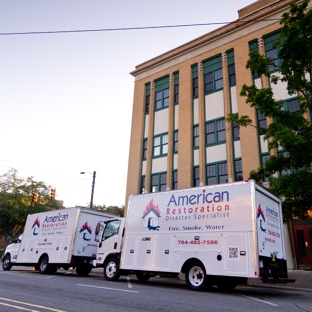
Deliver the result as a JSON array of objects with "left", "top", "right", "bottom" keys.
[{"left": 2, "top": 207, "right": 113, "bottom": 276}]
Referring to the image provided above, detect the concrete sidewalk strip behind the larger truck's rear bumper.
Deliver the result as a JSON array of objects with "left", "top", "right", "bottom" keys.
[{"left": 248, "top": 270, "right": 312, "bottom": 292}]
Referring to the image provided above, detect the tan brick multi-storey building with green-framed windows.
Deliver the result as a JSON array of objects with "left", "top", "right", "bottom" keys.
[{"left": 126, "top": 0, "right": 312, "bottom": 265}]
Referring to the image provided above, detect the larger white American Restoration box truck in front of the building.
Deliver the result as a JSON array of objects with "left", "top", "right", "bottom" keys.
[{"left": 94, "top": 180, "right": 294, "bottom": 290}]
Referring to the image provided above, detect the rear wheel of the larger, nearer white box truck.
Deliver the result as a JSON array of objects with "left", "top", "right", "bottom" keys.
[{"left": 185, "top": 261, "right": 208, "bottom": 290}]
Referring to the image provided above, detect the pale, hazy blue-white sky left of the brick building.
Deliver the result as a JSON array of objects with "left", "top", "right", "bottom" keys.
[{"left": 0, "top": 0, "right": 254, "bottom": 207}]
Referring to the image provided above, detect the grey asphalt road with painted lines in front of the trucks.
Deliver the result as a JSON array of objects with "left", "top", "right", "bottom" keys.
[{"left": 0, "top": 267, "right": 312, "bottom": 312}]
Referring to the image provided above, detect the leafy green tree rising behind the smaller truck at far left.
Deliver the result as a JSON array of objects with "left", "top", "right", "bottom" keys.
[{"left": 0, "top": 168, "right": 62, "bottom": 250}]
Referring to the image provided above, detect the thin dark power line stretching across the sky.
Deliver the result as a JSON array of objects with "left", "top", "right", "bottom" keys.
[{"left": 0, "top": 19, "right": 280, "bottom": 36}]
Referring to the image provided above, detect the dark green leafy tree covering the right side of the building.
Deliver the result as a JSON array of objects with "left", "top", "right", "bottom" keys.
[{"left": 227, "top": 0, "right": 312, "bottom": 219}]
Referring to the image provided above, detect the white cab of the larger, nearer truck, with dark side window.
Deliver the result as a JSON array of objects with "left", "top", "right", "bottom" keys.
[{"left": 96, "top": 219, "right": 124, "bottom": 266}]
